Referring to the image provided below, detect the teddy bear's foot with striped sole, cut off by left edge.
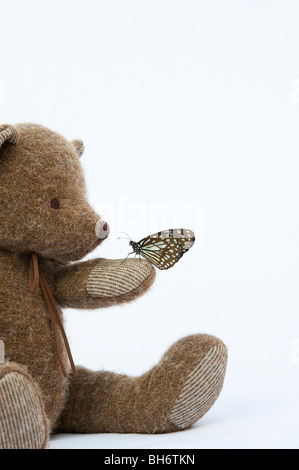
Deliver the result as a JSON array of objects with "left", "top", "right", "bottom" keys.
[{"left": 0, "top": 362, "right": 50, "bottom": 449}]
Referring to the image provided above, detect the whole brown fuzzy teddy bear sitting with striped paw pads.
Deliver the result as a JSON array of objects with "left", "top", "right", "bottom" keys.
[{"left": 0, "top": 123, "right": 227, "bottom": 449}]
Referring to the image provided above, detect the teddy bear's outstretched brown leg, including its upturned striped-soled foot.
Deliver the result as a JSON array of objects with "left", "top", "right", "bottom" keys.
[{"left": 59, "top": 335, "right": 227, "bottom": 433}]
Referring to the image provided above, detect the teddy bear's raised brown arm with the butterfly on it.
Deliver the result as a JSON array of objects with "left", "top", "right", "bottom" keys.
[{"left": 54, "top": 258, "right": 155, "bottom": 309}]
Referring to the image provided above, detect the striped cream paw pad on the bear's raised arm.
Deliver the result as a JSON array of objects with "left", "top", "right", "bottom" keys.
[{"left": 86, "top": 259, "right": 152, "bottom": 297}]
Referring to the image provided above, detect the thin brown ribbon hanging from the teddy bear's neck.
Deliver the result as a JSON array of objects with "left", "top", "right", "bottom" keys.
[{"left": 29, "top": 253, "right": 77, "bottom": 377}]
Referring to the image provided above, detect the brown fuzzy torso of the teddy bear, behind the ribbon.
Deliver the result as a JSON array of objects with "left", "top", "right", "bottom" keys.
[{"left": 0, "top": 251, "right": 69, "bottom": 425}]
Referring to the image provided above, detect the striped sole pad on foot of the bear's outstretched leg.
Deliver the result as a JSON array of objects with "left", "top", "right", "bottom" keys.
[{"left": 169, "top": 343, "right": 227, "bottom": 429}]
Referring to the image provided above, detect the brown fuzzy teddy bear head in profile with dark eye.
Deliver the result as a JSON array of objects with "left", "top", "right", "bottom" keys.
[{"left": 0, "top": 124, "right": 109, "bottom": 263}]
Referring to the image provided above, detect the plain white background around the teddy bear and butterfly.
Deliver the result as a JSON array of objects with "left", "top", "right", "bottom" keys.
[{"left": 0, "top": 0, "right": 299, "bottom": 449}]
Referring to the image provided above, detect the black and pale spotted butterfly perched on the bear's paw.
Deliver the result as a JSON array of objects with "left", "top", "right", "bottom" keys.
[{"left": 123, "top": 228, "right": 195, "bottom": 269}]
